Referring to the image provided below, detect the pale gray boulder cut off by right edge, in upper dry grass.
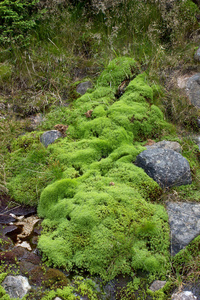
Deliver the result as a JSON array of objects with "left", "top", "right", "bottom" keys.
[{"left": 186, "top": 73, "right": 200, "bottom": 108}]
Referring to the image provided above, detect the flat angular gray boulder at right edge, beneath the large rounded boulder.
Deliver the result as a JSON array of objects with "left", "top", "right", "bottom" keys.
[{"left": 166, "top": 202, "right": 200, "bottom": 255}]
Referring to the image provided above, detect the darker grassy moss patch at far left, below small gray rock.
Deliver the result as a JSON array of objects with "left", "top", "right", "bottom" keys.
[{"left": 7, "top": 132, "right": 62, "bottom": 205}]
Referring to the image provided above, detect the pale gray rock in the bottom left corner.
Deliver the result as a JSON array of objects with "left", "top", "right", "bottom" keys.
[{"left": 1, "top": 275, "right": 31, "bottom": 299}]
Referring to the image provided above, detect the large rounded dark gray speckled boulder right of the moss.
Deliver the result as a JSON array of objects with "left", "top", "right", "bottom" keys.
[{"left": 135, "top": 148, "right": 192, "bottom": 188}]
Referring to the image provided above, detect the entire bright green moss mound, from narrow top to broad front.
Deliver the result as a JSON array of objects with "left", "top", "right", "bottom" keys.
[{"left": 6, "top": 58, "right": 170, "bottom": 280}]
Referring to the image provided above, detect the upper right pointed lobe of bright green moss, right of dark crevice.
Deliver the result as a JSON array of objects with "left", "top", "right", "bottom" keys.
[{"left": 108, "top": 74, "right": 168, "bottom": 140}]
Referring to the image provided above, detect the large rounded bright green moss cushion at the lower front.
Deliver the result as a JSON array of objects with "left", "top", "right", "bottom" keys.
[{"left": 38, "top": 173, "right": 169, "bottom": 280}]
